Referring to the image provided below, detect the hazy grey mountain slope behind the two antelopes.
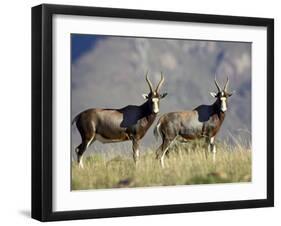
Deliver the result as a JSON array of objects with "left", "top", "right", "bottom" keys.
[{"left": 72, "top": 37, "right": 251, "bottom": 154}]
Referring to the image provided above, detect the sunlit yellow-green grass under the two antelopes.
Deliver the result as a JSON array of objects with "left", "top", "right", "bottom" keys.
[{"left": 72, "top": 139, "right": 252, "bottom": 190}]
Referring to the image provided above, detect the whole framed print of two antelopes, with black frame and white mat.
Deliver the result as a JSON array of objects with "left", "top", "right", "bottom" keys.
[{"left": 32, "top": 4, "right": 274, "bottom": 221}]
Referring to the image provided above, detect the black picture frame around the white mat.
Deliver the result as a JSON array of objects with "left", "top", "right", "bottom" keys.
[{"left": 31, "top": 4, "right": 274, "bottom": 221}]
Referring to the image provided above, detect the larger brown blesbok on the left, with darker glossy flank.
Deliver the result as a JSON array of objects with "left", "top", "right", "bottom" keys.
[{"left": 72, "top": 73, "right": 167, "bottom": 168}]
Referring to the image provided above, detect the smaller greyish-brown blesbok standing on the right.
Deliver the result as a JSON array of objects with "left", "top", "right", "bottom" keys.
[{"left": 154, "top": 77, "right": 232, "bottom": 167}]
